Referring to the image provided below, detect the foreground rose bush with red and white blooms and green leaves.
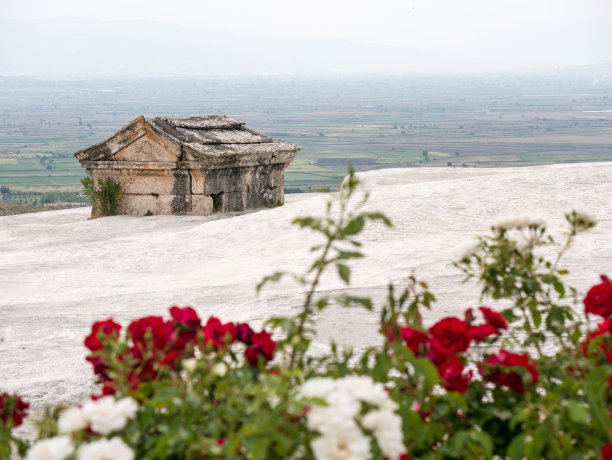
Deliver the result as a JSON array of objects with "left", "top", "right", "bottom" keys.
[{"left": 0, "top": 174, "right": 612, "bottom": 460}]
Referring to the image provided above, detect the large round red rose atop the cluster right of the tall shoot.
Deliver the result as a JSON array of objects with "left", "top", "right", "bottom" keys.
[{"left": 427, "top": 317, "right": 472, "bottom": 364}]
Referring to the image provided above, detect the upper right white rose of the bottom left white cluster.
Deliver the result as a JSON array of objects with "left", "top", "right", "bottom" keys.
[{"left": 81, "top": 396, "right": 138, "bottom": 434}]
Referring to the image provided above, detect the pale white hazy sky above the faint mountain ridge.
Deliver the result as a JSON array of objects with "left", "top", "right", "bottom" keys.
[{"left": 0, "top": 0, "right": 612, "bottom": 51}]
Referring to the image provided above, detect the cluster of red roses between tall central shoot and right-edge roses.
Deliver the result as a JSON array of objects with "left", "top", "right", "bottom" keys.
[{"left": 400, "top": 307, "right": 538, "bottom": 393}]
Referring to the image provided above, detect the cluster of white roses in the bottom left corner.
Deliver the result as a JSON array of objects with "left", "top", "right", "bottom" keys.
[{"left": 26, "top": 396, "right": 138, "bottom": 460}]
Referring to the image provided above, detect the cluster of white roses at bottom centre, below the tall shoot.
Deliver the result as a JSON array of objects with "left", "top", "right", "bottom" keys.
[{"left": 299, "top": 375, "right": 406, "bottom": 460}]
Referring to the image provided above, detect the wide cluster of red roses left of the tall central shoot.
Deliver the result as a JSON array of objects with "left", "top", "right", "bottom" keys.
[{"left": 85, "top": 307, "right": 276, "bottom": 394}]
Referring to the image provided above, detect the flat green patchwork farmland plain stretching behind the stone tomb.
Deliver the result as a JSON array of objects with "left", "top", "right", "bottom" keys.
[{"left": 0, "top": 76, "right": 612, "bottom": 205}]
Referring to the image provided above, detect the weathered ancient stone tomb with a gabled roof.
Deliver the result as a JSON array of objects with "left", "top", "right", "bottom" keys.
[{"left": 74, "top": 115, "right": 300, "bottom": 216}]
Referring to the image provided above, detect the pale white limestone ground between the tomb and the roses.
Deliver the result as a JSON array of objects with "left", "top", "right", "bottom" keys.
[{"left": 0, "top": 163, "right": 612, "bottom": 407}]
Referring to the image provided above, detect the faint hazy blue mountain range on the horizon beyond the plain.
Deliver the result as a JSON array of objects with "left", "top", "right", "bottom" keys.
[{"left": 0, "top": 18, "right": 612, "bottom": 78}]
